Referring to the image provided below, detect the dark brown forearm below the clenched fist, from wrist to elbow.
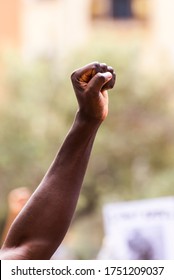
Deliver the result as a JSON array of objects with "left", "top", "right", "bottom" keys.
[{"left": 2, "top": 113, "right": 100, "bottom": 258}]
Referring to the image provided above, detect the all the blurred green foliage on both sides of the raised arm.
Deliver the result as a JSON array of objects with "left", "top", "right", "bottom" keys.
[{"left": 0, "top": 40, "right": 174, "bottom": 258}]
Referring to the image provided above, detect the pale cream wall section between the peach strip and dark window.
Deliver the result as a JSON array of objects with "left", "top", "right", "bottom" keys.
[{"left": 22, "top": 0, "right": 90, "bottom": 57}]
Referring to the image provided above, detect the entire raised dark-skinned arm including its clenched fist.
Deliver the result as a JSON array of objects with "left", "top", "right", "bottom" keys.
[{"left": 0, "top": 62, "right": 115, "bottom": 260}]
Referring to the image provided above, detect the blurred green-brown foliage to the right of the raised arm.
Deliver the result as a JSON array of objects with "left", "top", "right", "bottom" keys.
[{"left": 69, "top": 42, "right": 174, "bottom": 214}]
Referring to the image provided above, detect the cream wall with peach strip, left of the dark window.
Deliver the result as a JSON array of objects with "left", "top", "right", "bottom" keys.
[{"left": 0, "top": 0, "right": 91, "bottom": 58}]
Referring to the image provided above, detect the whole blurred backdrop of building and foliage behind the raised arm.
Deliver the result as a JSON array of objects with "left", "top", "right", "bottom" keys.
[{"left": 0, "top": 0, "right": 174, "bottom": 259}]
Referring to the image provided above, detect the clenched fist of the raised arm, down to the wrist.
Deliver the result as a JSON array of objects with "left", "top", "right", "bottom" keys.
[{"left": 71, "top": 62, "right": 116, "bottom": 122}]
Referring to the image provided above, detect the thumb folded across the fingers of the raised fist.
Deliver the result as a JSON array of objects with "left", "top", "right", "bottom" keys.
[{"left": 87, "top": 72, "right": 112, "bottom": 94}]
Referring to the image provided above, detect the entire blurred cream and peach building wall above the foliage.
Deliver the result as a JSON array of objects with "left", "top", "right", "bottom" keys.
[{"left": 0, "top": 0, "right": 174, "bottom": 64}]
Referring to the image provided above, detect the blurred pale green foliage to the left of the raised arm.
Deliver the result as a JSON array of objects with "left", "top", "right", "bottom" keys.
[{"left": 0, "top": 57, "right": 76, "bottom": 212}]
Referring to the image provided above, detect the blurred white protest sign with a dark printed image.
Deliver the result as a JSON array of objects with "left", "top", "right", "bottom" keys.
[{"left": 98, "top": 197, "right": 174, "bottom": 260}]
